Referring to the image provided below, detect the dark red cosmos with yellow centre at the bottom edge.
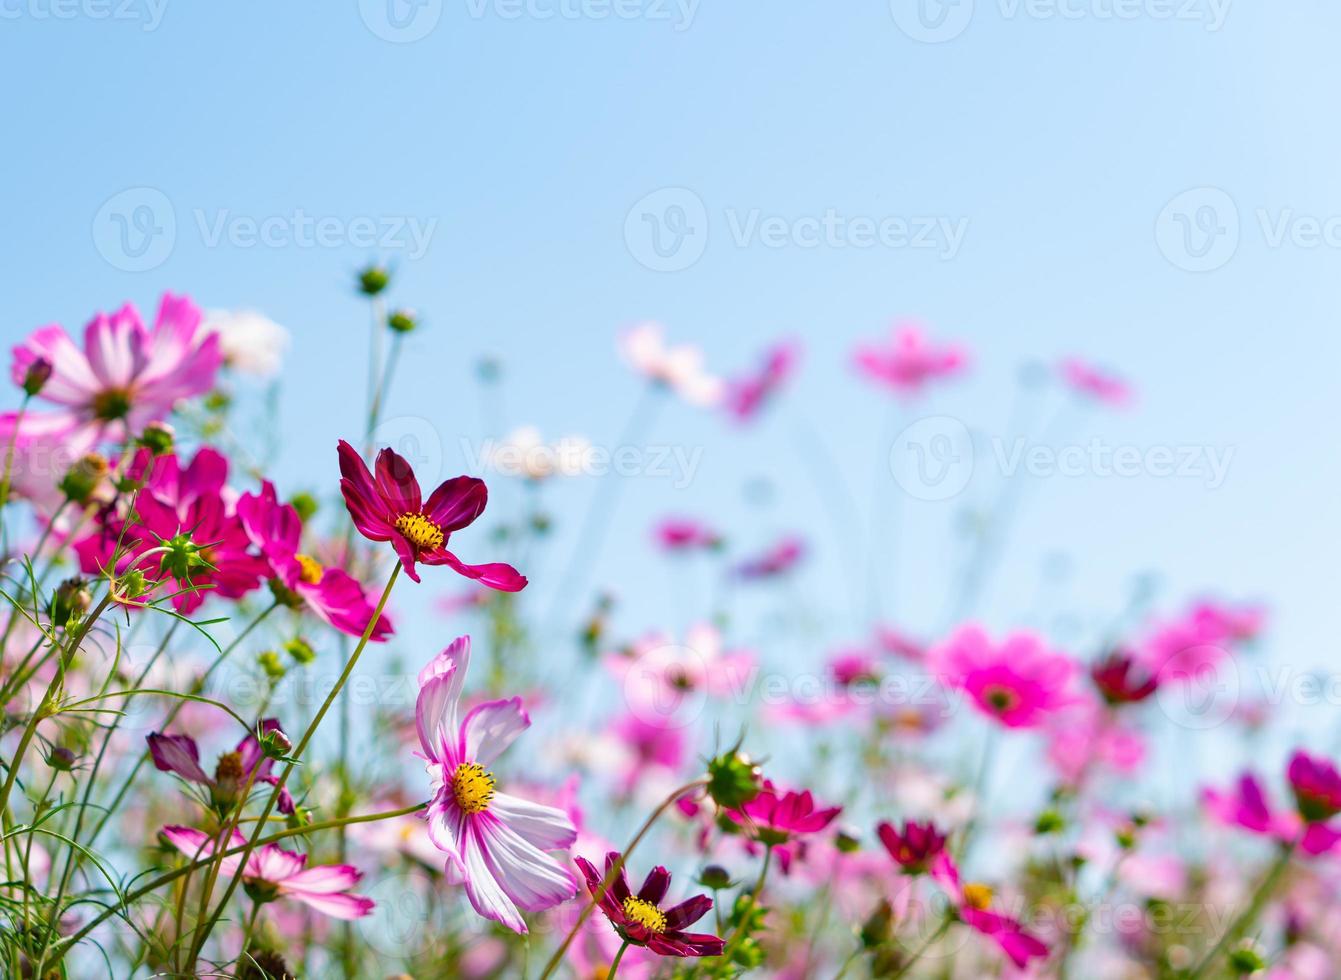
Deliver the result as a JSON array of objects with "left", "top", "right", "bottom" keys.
[{"left": 574, "top": 851, "right": 724, "bottom": 956}]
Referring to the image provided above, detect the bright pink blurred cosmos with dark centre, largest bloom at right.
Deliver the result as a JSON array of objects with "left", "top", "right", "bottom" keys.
[{"left": 928, "top": 625, "right": 1077, "bottom": 728}]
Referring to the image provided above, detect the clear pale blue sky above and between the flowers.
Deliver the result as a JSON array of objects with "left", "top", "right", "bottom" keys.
[{"left": 0, "top": 0, "right": 1341, "bottom": 761}]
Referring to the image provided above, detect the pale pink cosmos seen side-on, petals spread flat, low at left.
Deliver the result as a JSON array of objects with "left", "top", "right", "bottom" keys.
[{"left": 162, "top": 826, "right": 375, "bottom": 918}]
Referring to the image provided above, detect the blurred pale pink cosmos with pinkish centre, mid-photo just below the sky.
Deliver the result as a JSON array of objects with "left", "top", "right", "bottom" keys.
[{"left": 606, "top": 623, "right": 755, "bottom": 717}]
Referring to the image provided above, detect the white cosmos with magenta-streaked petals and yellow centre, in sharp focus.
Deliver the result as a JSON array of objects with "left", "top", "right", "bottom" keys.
[{"left": 414, "top": 637, "right": 577, "bottom": 933}]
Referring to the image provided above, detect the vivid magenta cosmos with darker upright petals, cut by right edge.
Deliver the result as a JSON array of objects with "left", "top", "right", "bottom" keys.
[{"left": 1202, "top": 752, "right": 1341, "bottom": 855}]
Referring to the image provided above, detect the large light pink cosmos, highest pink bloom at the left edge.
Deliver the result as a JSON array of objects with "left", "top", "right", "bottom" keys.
[{"left": 0, "top": 292, "right": 223, "bottom": 438}]
